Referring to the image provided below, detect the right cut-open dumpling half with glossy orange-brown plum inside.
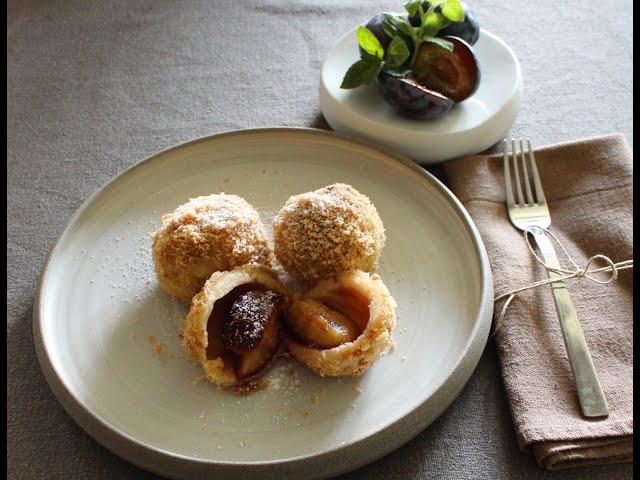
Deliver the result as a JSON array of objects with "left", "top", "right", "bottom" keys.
[{"left": 285, "top": 271, "right": 396, "bottom": 376}]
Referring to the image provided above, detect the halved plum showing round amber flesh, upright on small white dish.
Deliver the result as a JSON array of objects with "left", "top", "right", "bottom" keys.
[{"left": 413, "top": 37, "right": 480, "bottom": 103}]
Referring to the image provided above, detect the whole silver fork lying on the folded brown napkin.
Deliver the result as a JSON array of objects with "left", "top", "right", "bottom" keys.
[{"left": 503, "top": 140, "right": 609, "bottom": 417}]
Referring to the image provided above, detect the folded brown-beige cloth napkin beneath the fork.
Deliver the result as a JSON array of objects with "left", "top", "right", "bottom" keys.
[{"left": 443, "top": 134, "right": 633, "bottom": 470}]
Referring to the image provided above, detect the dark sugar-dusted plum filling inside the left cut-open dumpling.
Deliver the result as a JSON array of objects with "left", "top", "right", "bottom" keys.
[{"left": 207, "top": 283, "right": 284, "bottom": 380}]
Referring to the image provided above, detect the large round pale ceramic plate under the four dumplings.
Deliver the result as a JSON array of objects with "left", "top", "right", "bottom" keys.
[{"left": 34, "top": 128, "right": 492, "bottom": 479}]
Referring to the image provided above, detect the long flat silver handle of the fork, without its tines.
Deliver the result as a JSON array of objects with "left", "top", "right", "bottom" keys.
[{"left": 529, "top": 227, "right": 609, "bottom": 417}]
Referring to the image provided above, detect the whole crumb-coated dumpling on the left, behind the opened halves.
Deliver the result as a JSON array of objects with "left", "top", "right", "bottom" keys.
[{"left": 152, "top": 193, "right": 273, "bottom": 303}]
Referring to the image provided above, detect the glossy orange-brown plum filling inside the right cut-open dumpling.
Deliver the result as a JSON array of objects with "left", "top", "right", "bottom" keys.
[{"left": 286, "top": 288, "right": 369, "bottom": 350}]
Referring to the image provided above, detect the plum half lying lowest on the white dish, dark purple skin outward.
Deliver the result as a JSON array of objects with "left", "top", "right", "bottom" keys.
[{"left": 376, "top": 72, "right": 454, "bottom": 120}]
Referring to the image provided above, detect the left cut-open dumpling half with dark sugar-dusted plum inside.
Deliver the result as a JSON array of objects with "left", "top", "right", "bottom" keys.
[{"left": 183, "top": 264, "right": 288, "bottom": 387}]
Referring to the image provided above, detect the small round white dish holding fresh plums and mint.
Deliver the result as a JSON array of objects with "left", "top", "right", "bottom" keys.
[{"left": 320, "top": 30, "right": 522, "bottom": 164}]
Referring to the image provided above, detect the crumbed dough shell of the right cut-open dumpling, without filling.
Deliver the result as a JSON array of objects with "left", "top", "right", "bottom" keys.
[{"left": 286, "top": 271, "right": 396, "bottom": 377}]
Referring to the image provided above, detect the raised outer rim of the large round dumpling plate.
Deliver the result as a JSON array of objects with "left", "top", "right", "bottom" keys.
[{"left": 32, "top": 126, "right": 493, "bottom": 478}]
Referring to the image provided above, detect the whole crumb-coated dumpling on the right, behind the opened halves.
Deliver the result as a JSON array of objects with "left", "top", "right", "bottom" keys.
[{"left": 273, "top": 183, "right": 385, "bottom": 285}]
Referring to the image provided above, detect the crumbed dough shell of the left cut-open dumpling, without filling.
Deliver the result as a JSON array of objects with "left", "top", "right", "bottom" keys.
[{"left": 182, "top": 264, "right": 287, "bottom": 387}]
